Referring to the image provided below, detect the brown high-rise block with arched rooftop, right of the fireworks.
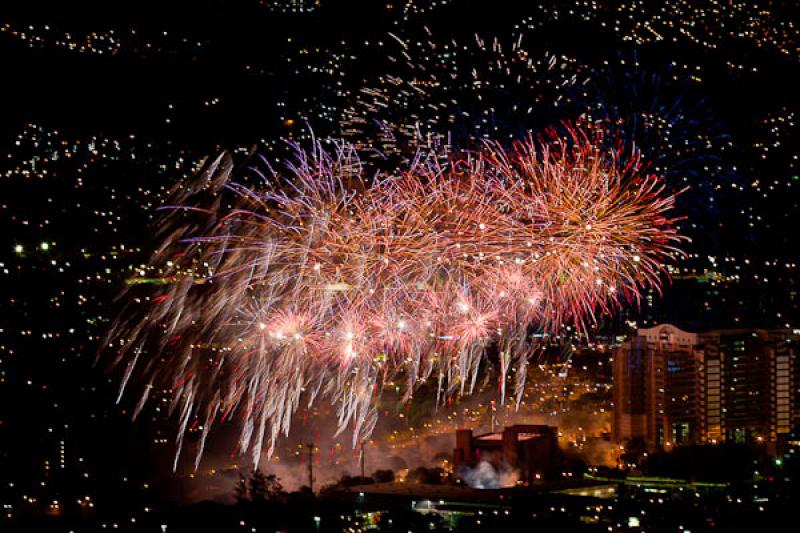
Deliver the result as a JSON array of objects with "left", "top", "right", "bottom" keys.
[{"left": 613, "top": 324, "right": 800, "bottom": 449}]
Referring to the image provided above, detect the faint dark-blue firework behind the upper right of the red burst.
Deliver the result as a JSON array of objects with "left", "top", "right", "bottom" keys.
[{"left": 571, "top": 52, "right": 743, "bottom": 238}]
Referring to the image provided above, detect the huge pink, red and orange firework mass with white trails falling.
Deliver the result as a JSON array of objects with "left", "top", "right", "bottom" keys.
[{"left": 104, "top": 128, "right": 681, "bottom": 465}]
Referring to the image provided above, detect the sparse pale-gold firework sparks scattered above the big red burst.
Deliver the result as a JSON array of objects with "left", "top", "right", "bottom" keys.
[{"left": 340, "top": 29, "right": 588, "bottom": 156}]
